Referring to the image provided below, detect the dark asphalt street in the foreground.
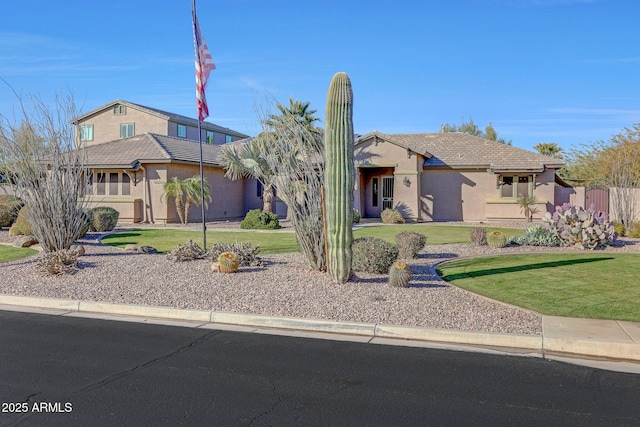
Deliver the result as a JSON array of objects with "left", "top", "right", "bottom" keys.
[{"left": 0, "top": 311, "right": 640, "bottom": 426}]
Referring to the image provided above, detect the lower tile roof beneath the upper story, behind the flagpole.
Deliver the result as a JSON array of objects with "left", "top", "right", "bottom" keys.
[{"left": 84, "top": 133, "right": 228, "bottom": 168}]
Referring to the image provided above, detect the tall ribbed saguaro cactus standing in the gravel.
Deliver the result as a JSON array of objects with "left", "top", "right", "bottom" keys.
[{"left": 324, "top": 73, "right": 354, "bottom": 283}]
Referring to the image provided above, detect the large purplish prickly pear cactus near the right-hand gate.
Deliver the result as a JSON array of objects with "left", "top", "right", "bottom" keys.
[{"left": 542, "top": 203, "right": 617, "bottom": 249}]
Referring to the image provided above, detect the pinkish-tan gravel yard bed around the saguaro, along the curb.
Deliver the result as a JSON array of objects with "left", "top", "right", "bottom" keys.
[{"left": 0, "top": 226, "right": 638, "bottom": 340}]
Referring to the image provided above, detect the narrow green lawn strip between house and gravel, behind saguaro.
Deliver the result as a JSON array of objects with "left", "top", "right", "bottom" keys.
[{"left": 102, "top": 224, "right": 523, "bottom": 254}]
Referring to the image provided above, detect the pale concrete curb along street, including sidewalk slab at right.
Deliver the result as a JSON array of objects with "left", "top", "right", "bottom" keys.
[{"left": 0, "top": 295, "right": 640, "bottom": 364}]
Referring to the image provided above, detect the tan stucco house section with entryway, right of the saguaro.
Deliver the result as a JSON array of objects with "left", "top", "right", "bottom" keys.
[{"left": 354, "top": 131, "right": 568, "bottom": 221}]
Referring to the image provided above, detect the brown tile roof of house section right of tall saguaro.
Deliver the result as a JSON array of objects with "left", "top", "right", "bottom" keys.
[{"left": 356, "top": 131, "right": 564, "bottom": 172}]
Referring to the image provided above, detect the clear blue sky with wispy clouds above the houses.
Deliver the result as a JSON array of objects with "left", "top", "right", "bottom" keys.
[{"left": 0, "top": 0, "right": 640, "bottom": 154}]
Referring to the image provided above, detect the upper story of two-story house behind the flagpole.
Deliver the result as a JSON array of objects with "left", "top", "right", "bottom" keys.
[{"left": 73, "top": 99, "right": 248, "bottom": 146}]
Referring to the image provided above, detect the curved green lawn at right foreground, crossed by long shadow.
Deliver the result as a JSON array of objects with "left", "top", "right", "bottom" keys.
[{"left": 437, "top": 252, "right": 640, "bottom": 322}]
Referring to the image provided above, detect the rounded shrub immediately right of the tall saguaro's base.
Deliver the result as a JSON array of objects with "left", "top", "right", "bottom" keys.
[{"left": 351, "top": 237, "right": 399, "bottom": 273}]
